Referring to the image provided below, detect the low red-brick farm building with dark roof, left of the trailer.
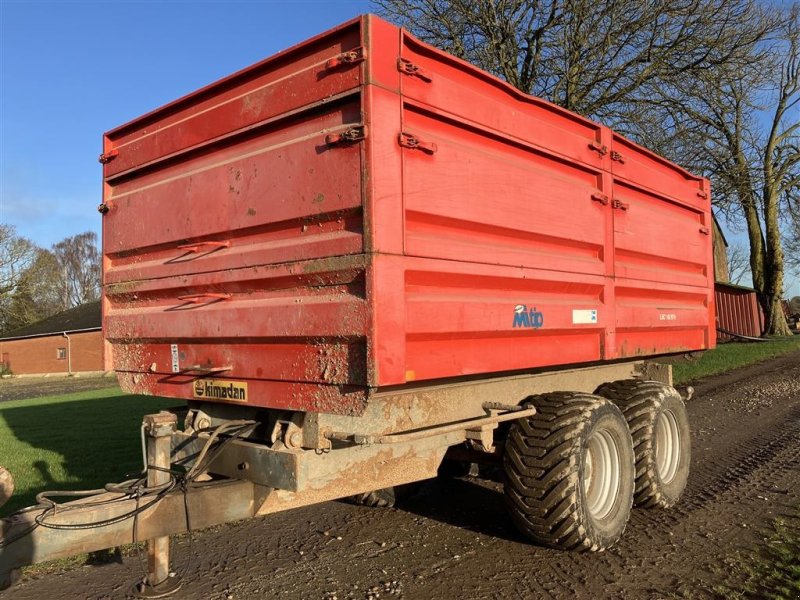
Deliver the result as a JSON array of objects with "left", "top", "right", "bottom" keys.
[{"left": 0, "top": 301, "right": 104, "bottom": 375}]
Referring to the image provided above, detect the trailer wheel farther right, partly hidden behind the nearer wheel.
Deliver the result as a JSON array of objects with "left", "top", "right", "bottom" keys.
[{"left": 595, "top": 379, "right": 692, "bottom": 508}]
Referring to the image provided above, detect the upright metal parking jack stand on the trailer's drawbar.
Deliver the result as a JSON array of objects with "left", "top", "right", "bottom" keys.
[{"left": 134, "top": 411, "right": 181, "bottom": 598}]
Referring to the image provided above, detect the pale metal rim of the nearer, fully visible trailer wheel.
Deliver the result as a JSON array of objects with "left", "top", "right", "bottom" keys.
[{"left": 583, "top": 429, "right": 620, "bottom": 519}]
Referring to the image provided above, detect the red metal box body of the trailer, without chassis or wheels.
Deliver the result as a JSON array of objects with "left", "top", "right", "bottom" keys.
[{"left": 102, "top": 16, "right": 715, "bottom": 414}]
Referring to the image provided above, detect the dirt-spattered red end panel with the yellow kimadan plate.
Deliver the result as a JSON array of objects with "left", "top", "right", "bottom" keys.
[{"left": 104, "top": 21, "right": 369, "bottom": 411}]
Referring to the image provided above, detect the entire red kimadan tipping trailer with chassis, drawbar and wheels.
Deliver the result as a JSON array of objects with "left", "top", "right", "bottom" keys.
[{"left": 0, "top": 15, "right": 716, "bottom": 594}]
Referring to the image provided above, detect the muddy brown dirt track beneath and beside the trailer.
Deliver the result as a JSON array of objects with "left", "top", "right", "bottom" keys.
[{"left": 0, "top": 353, "right": 800, "bottom": 600}]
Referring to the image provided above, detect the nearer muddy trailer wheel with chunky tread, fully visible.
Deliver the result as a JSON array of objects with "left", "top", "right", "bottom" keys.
[{"left": 503, "top": 392, "right": 634, "bottom": 551}]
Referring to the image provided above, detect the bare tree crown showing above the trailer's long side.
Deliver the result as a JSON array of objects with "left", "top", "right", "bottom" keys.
[{"left": 375, "top": 0, "right": 772, "bottom": 126}]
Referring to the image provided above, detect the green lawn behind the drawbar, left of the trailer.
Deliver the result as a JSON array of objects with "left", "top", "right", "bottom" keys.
[{"left": 0, "top": 390, "right": 174, "bottom": 515}]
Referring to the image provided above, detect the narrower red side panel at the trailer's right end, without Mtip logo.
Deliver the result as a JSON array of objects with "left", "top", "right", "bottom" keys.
[{"left": 611, "top": 135, "right": 716, "bottom": 358}]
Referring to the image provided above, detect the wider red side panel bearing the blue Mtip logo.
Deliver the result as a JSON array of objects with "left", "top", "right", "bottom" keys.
[{"left": 390, "top": 36, "right": 613, "bottom": 382}]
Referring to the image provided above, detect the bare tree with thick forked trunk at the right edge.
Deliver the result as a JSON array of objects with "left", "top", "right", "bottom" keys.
[{"left": 654, "top": 5, "right": 800, "bottom": 335}]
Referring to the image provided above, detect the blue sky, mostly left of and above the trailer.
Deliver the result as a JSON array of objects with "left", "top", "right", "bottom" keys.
[{"left": 0, "top": 0, "right": 800, "bottom": 296}]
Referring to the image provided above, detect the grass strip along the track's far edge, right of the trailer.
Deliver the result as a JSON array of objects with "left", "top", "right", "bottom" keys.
[{"left": 672, "top": 335, "right": 800, "bottom": 383}]
